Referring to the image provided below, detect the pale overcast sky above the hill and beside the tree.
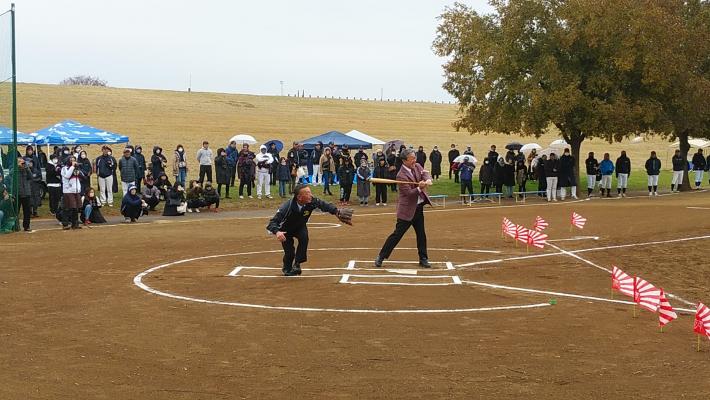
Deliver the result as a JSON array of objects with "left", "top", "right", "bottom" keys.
[{"left": 8, "top": 0, "right": 490, "bottom": 100}]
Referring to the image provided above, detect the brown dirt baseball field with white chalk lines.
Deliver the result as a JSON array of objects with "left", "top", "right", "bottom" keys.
[{"left": 0, "top": 192, "right": 710, "bottom": 400}]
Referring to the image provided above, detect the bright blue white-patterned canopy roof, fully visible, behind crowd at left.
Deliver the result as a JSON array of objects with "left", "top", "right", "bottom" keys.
[{"left": 33, "top": 120, "right": 128, "bottom": 146}]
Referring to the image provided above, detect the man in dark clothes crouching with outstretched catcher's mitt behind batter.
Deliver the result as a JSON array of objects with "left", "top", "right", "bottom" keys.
[{"left": 266, "top": 185, "right": 353, "bottom": 276}]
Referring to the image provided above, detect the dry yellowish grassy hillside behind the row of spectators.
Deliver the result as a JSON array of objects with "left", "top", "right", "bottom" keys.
[{"left": 18, "top": 84, "right": 668, "bottom": 168}]
